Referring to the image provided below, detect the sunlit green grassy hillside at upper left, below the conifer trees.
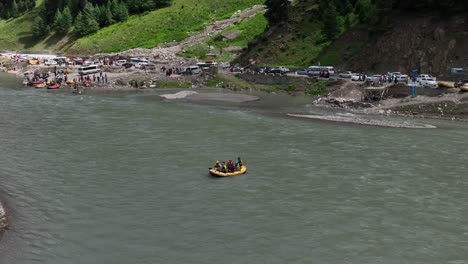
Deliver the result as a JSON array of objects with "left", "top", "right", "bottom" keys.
[{"left": 0, "top": 0, "right": 264, "bottom": 54}]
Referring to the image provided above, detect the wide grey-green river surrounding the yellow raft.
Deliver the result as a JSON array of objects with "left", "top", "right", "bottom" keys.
[{"left": 0, "top": 74, "right": 468, "bottom": 264}]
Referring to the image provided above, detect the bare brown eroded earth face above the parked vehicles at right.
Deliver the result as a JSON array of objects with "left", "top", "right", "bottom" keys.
[{"left": 321, "top": 14, "right": 468, "bottom": 76}]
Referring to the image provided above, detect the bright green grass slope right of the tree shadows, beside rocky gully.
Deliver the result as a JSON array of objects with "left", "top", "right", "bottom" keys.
[{"left": 69, "top": 0, "right": 264, "bottom": 53}]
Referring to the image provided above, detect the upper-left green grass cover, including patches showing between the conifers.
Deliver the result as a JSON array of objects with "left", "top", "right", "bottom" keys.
[{"left": 0, "top": 0, "right": 264, "bottom": 54}]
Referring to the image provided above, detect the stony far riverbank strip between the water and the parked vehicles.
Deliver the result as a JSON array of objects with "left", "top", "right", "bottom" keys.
[{"left": 4, "top": 55, "right": 468, "bottom": 122}]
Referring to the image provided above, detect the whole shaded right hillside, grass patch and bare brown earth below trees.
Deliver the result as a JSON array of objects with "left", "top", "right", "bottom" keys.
[{"left": 239, "top": 0, "right": 468, "bottom": 78}]
